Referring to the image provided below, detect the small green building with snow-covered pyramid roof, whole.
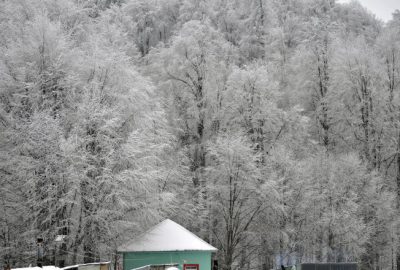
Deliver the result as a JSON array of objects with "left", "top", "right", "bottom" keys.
[{"left": 118, "top": 219, "right": 217, "bottom": 270}]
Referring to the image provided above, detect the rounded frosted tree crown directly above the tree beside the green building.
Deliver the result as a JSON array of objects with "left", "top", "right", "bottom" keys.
[{"left": 222, "top": 62, "right": 285, "bottom": 155}]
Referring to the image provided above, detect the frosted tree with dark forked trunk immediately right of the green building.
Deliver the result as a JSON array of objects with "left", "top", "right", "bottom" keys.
[{"left": 207, "top": 135, "right": 274, "bottom": 269}]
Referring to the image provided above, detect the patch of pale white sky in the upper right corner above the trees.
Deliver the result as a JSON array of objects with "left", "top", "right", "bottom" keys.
[{"left": 338, "top": 0, "right": 400, "bottom": 22}]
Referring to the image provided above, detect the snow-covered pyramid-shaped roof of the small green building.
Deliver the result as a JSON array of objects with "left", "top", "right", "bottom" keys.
[{"left": 118, "top": 219, "right": 217, "bottom": 252}]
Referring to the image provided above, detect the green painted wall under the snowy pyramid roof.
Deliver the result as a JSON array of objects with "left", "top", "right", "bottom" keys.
[{"left": 123, "top": 251, "right": 211, "bottom": 270}]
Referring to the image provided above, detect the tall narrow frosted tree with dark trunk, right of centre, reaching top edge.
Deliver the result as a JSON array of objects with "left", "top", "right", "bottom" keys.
[{"left": 293, "top": 1, "right": 337, "bottom": 150}]
